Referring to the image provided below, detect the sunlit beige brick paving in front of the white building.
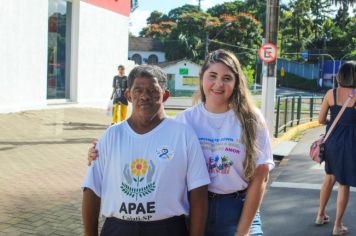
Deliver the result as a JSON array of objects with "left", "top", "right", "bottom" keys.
[{"left": 0, "top": 108, "right": 110, "bottom": 236}]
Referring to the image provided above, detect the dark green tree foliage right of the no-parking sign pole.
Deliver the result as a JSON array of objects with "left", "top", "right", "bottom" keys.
[{"left": 279, "top": 0, "right": 356, "bottom": 62}]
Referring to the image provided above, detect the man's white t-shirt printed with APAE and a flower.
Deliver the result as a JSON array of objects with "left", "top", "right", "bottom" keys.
[{"left": 82, "top": 118, "right": 210, "bottom": 221}]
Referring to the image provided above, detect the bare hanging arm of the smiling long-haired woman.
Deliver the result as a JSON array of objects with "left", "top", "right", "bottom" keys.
[{"left": 235, "top": 164, "right": 269, "bottom": 236}]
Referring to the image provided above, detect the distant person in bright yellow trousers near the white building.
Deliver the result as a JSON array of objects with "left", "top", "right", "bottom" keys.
[{"left": 110, "top": 65, "right": 128, "bottom": 124}]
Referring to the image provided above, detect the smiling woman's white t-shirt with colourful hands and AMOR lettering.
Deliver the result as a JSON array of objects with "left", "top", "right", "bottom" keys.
[{"left": 176, "top": 103, "right": 274, "bottom": 194}]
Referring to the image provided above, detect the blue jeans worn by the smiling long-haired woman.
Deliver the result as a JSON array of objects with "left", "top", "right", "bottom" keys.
[{"left": 205, "top": 193, "right": 263, "bottom": 236}]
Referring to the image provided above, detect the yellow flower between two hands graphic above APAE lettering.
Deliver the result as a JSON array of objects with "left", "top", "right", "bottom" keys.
[{"left": 120, "top": 158, "right": 156, "bottom": 200}]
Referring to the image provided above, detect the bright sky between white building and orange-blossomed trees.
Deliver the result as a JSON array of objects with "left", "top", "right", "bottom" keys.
[{"left": 130, "top": 0, "right": 229, "bottom": 36}]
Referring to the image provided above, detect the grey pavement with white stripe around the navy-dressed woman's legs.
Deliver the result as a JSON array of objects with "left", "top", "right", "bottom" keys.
[{"left": 261, "top": 126, "right": 356, "bottom": 236}]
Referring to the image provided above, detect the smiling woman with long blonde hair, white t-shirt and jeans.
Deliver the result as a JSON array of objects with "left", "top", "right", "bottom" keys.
[{"left": 176, "top": 50, "right": 274, "bottom": 236}]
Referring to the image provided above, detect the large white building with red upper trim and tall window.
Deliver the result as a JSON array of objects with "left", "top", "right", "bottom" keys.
[{"left": 0, "top": 0, "right": 130, "bottom": 112}]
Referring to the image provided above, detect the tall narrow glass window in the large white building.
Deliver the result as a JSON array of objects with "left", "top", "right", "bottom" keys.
[{"left": 47, "top": 0, "right": 72, "bottom": 99}]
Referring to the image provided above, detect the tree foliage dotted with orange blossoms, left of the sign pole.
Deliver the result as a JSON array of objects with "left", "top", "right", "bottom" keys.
[{"left": 140, "top": 1, "right": 262, "bottom": 65}]
